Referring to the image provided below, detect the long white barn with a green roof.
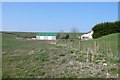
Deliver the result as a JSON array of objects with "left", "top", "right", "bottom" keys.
[{"left": 36, "top": 32, "right": 58, "bottom": 40}]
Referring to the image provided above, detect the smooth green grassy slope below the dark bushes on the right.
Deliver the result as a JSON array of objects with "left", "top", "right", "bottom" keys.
[{"left": 81, "top": 33, "right": 120, "bottom": 63}]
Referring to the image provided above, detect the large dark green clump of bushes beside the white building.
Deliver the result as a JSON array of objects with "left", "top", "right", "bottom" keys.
[{"left": 92, "top": 21, "right": 120, "bottom": 38}]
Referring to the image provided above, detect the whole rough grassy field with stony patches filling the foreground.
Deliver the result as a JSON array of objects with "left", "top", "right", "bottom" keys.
[{"left": 2, "top": 33, "right": 119, "bottom": 78}]
